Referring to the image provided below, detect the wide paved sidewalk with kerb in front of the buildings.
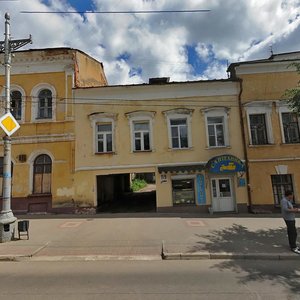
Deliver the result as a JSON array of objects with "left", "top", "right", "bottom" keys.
[{"left": 0, "top": 213, "right": 300, "bottom": 261}]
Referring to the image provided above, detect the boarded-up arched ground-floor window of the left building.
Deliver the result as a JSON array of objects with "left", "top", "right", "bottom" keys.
[{"left": 33, "top": 154, "right": 52, "bottom": 194}]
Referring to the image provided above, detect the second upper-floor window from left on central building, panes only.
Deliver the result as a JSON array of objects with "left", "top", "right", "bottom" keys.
[{"left": 133, "top": 121, "right": 150, "bottom": 151}]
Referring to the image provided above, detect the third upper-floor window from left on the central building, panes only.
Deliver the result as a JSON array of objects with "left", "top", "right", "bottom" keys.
[{"left": 170, "top": 119, "right": 189, "bottom": 149}]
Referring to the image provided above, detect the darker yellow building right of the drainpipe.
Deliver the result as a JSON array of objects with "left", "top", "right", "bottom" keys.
[{"left": 229, "top": 52, "right": 300, "bottom": 210}]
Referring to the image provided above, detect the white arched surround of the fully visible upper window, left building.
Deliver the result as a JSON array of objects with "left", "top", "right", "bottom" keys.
[{"left": 31, "top": 83, "right": 56, "bottom": 123}]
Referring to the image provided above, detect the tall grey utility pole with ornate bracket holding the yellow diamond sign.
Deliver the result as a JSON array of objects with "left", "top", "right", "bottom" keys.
[{"left": 0, "top": 13, "right": 32, "bottom": 243}]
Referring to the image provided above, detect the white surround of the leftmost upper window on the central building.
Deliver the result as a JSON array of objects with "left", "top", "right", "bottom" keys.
[{"left": 89, "top": 113, "right": 117, "bottom": 154}]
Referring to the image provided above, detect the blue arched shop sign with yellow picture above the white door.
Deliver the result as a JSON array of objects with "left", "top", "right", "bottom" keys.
[{"left": 206, "top": 154, "right": 245, "bottom": 173}]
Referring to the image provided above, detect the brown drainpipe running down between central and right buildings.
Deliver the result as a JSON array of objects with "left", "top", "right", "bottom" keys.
[{"left": 238, "top": 78, "right": 252, "bottom": 212}]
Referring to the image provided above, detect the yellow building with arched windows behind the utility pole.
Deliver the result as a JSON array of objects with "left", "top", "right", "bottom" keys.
[{"left": 0, "top": 48, "right": 107, "bottom": 213}]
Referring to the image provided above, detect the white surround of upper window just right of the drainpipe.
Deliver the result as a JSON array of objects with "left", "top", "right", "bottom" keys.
[{"left": 244, "top": 100, "right": 274, "bottom": 147}]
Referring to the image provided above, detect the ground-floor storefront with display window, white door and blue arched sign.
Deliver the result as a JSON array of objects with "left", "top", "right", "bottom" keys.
[{"left": 157, "top": 155, "right": 248, "bottom": 213}]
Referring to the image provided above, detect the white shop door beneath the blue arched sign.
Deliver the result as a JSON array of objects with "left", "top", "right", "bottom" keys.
[{"left": 211, "top": 178, "right": 235, "bottom": 212}]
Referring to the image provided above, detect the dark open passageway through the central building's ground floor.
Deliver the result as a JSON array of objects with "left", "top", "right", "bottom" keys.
[{"left": 97, "top": 173, "right": 156, "bottom": 213}]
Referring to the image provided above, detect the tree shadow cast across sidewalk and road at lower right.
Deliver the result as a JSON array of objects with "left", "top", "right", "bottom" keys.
[{"left": 190, "top": 224, "right": 300, "bottom": 295}]
